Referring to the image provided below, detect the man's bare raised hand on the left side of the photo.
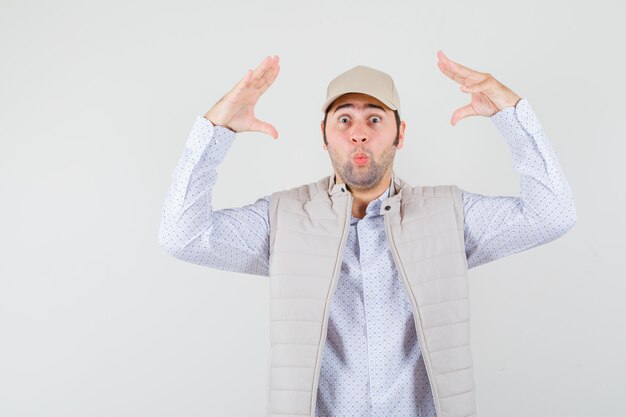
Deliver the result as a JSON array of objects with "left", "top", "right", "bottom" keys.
[{"left": 204, "top": 55, "right": 280, "bottom": 139}]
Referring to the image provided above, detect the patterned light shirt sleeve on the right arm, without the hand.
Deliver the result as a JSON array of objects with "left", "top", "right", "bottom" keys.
[{"left": 462, "top": 98, "right": 576, "bottom": 268}]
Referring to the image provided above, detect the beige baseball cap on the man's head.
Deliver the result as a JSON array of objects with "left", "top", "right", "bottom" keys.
[{"left": 322, "top": 65, "right": 400, "bottom": 113}]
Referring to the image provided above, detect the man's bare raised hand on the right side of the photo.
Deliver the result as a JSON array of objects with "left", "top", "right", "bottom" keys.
[{"left": 437, "top": 51, "right": 521, "bottom": 126}]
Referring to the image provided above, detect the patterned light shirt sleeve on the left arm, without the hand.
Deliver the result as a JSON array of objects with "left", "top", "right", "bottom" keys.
[{"left": 159, "top": 116, "right": 270, "bottom": 276}]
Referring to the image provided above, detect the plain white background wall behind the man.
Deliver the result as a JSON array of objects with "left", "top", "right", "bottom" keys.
[{"left": 0, "top": 0, "right": 626, "bottom": 417}]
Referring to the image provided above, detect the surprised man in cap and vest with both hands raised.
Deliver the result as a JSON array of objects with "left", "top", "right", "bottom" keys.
[{"left": 159, "top": 52, "right": 576, "bottom": 417}]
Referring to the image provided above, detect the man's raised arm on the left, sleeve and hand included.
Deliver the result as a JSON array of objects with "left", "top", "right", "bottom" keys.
[{"left": 159, "top": 56, "right": 279, "bottom": 276}]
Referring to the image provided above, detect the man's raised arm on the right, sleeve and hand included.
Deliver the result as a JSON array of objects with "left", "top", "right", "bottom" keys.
[{"left": 437, "top": 51, "right": 576, "bottom": 268}]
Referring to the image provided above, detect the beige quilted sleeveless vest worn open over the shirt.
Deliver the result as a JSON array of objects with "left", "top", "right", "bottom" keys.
[{"left": 267, "top": 175, "right": 476, "bottom": 417}]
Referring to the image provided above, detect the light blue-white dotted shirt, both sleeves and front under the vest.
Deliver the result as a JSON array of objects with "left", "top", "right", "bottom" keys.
[{"left": 159, "top": 99, "right": 576, "bottom": 417}]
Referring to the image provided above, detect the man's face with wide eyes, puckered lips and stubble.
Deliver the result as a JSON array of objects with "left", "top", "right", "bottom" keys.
[{"left": 321, "top": 93, "right": 406, "bottom": 191}]
